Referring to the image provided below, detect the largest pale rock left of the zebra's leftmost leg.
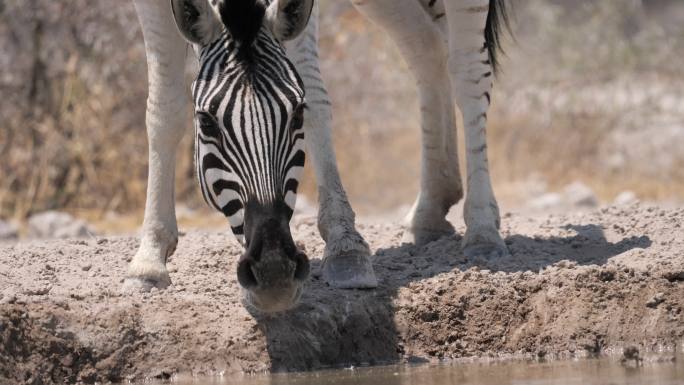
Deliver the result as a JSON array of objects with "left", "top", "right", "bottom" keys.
[{"left": 28, "top": 211, "right": 94, "bottom": 238}]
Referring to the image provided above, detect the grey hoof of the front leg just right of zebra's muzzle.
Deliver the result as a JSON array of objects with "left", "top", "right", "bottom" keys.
[{"left": 322, "top": 252, "right": 378, "bottom": 289}]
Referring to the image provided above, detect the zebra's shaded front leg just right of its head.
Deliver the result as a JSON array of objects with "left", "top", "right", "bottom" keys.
[{"left": 286, "top": 2, "right": 378, "bottom": 288}]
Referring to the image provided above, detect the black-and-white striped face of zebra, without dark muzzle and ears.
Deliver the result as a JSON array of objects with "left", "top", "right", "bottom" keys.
[{"left": 192, "top": 27, "right": 305, "bottom": 241}]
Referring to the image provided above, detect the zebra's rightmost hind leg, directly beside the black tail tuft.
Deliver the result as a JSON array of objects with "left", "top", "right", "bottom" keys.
[{"left": 444, "top": 0, "right": 506, "bottom": 257}]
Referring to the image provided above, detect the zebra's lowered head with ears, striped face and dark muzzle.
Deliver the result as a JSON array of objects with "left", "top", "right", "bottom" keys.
[{"left": 171, "top": 0, "right": 313, "bottom": 312}]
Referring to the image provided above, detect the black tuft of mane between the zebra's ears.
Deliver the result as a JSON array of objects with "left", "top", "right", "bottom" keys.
[{"left": 218, "top": 0, "right": 266, "bottom": 51}]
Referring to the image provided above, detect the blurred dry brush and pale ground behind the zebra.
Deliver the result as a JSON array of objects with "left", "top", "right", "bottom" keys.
[{"left": 0, "top": 0, "right": 684, "bottom": 237}]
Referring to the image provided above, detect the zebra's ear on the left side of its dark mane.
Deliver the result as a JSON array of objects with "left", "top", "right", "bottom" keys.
[{"left": 171, "top": 0, "right": 221, "bottom": 45}]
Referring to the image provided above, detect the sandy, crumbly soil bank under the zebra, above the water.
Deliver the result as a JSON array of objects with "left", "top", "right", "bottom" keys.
[{"left": 0, "top": 205, "right": 684, "bottom": 384}]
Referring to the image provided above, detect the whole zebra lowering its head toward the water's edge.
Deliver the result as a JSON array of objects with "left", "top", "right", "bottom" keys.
[{"left": 124, "top": 0, "right": 507, "bottom": 312}]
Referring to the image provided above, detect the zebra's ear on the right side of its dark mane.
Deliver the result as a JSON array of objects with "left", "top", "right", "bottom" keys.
[{"left": 266, "top": 0, "right": 314, "bottom": 40}]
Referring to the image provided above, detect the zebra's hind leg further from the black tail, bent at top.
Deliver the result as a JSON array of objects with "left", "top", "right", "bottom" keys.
[{"left": 353, "top": 0, "right": 463, "bottom": 244}]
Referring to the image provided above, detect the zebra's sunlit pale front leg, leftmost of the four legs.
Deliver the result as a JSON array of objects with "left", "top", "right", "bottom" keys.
[{"left": 124, "top": 0, "right": 187, "bottom": 290}]
